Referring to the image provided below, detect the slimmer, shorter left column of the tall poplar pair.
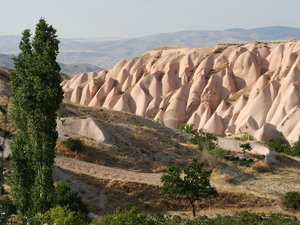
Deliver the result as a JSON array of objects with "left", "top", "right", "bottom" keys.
[{"left": 9, "top": 30, "right": 35, "bottom": 213}]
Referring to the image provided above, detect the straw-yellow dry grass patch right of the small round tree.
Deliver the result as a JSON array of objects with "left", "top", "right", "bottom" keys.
[{"left": 212, "top": 154, "right": 300, "bottom": 203}]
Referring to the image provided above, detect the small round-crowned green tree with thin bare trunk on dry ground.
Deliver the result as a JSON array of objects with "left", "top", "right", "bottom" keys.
[{"left": 161, "top": 159, "right": 217, "bottom": 217}]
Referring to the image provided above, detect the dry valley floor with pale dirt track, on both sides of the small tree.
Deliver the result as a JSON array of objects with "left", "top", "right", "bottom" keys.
[{"left": 54, "top": 153, "right": 300, "bottom": 218}]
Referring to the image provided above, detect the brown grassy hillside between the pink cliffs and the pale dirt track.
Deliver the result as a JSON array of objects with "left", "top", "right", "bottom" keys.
[{"left": 57, "top": 102, "right": 199, "bottom": 172}]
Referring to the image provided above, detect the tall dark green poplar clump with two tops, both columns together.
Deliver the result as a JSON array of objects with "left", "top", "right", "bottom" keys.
[{"left": 10, "top": 19, "right": 63, "bottom": 214}]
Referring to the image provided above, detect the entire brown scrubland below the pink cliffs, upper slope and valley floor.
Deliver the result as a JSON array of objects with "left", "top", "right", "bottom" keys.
[{"left": 52, "top": 102, "right": 300, "bottom": 216}]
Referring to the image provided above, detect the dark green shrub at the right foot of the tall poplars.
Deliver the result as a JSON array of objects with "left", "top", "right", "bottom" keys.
[{"left": 53, "top": 184, "right": 88, "bottom": 219}]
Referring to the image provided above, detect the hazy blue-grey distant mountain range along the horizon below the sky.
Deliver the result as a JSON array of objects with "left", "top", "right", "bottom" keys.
[{"left": 0, "top": 26, "right": 300, "bottom": 68}]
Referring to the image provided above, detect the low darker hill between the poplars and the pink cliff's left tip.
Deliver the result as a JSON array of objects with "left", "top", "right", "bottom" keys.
[{"left": 0, "top": 54, "right": 102, "bottom": 74}]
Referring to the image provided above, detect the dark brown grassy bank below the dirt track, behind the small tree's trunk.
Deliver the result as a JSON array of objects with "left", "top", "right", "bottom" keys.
[{"left": 62, "top": 169, "right": 278, "bottom": 215}]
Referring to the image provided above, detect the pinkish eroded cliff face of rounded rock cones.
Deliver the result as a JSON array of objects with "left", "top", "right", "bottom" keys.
[{"left": 62, "top": 40, "right": 300, "bottom": 143}]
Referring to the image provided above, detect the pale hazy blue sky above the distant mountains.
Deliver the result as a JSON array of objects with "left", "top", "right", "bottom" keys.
[{"left": 0, "top": 0, "right": 300, "bottom": 38}]
